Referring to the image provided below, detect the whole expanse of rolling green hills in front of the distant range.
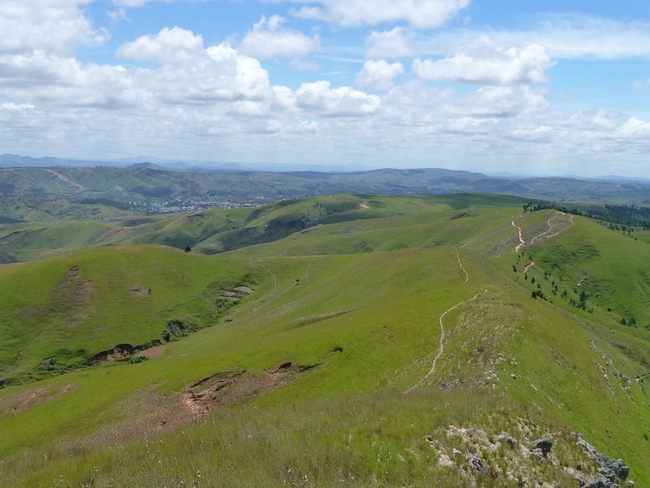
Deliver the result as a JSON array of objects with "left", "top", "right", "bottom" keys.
[{"left": 0, "top": 195, "right": 650, "bottom": 487}]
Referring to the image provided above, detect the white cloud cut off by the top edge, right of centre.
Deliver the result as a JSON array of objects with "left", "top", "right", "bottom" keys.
[{"left": 275, "top": 0, "right": 471, "bottom": 29}]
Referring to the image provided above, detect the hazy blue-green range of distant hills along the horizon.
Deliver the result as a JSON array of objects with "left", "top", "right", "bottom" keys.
[{"left": 0, "top": 154, "right": 650, "bottom": 205}]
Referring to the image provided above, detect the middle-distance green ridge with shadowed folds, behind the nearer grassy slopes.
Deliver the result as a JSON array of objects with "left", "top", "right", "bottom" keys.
[{"left": 0, "top": 194, "right": 523, "bottom": 263}]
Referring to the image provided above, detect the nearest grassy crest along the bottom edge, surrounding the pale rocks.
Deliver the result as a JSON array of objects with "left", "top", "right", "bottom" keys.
[{"left": 3, "top": 391, "right": 594, "bottom": 487}]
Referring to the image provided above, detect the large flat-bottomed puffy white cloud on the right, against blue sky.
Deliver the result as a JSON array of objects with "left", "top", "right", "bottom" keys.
[{"left": 412, "top": 36, "right": 555, "bottom": 86}]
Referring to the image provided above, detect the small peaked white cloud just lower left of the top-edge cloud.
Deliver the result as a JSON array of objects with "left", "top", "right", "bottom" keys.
[{"left": 238, "top": 15, "right": 319, "bottom": 59}]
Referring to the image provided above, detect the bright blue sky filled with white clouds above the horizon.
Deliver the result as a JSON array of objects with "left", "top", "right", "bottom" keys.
[{"left": 0, "top": 0, "right": 650, "bottom": 178}]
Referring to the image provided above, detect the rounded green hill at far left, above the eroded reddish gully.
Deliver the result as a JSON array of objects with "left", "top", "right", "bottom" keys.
[{"left": 0, "top": 246, "right": 250, "bottom": 379}]
